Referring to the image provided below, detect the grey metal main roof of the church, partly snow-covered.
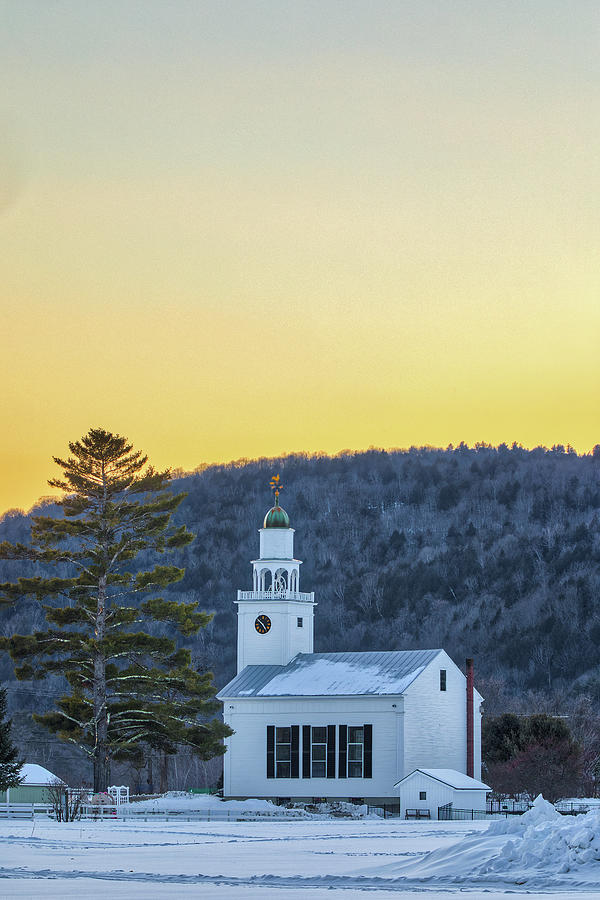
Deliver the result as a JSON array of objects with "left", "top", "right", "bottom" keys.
[{"left": 217, "top": 650, "right": 441, "bottom": 698}]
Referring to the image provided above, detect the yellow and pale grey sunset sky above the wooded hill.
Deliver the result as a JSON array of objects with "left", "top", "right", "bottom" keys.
[{"left": 0, "top": 0, "right": 600, "bottom": 512}]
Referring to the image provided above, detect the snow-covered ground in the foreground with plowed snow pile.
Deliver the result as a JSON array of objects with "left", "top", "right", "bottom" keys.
[{"left": 0, "top": 801, "right": 600, "bottom": 900}]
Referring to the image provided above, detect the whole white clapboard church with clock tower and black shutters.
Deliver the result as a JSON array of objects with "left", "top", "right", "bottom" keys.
[{"left": 217, "top": 491, "right": 490, "bottom": 818}]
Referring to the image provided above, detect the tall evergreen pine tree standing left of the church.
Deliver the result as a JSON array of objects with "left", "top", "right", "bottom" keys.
[{"left": 0, "top": 429, "right": 230, "bottom": 791}]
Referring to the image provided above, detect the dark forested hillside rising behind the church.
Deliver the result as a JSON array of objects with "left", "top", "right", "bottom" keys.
[{"left": 0, "top": 445, "right": 600, "bottom": 788}]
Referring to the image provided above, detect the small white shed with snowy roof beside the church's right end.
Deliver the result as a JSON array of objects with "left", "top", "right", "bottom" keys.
[{"left": 395, "top": 769, "right": 491, "bottom": 819}]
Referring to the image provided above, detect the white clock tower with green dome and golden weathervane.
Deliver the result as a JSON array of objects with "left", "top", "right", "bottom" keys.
[{"left": 236, "top": 475, "right": 316, "bottom": 673}]
